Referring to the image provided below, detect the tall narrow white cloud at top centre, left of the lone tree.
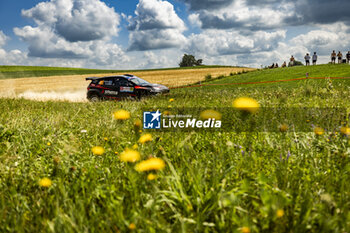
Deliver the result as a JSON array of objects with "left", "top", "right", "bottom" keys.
[{"left": 129, "top": 0, "right": 186, "bottom": 51}]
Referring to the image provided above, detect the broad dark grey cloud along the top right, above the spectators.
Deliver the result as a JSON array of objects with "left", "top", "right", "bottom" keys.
[{"left": 180, "top": 0, "right": 350, "bottom": 30}]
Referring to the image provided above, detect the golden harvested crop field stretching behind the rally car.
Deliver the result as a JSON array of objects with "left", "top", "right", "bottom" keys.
[{"left": 0, "top": 66, "right": 253, "bottom": 102}]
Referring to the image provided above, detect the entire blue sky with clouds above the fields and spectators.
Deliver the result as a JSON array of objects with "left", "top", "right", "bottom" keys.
[{"left": 0, "top": 0, "right": 350, "bottom": 69}]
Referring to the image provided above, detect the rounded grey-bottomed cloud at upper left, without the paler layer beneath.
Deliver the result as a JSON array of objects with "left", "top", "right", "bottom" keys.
[{"left": 22, "top": 0, "right": 120, "bottom": 42}]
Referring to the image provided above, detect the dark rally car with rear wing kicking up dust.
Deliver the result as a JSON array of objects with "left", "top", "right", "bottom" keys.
[{"left": 86, "top": 74, "right": 169, "bottom": 102}]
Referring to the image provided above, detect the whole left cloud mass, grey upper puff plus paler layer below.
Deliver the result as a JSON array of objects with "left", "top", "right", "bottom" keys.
[{"left": 10, "top": 0, "right": 130, "bottom": 69}]
